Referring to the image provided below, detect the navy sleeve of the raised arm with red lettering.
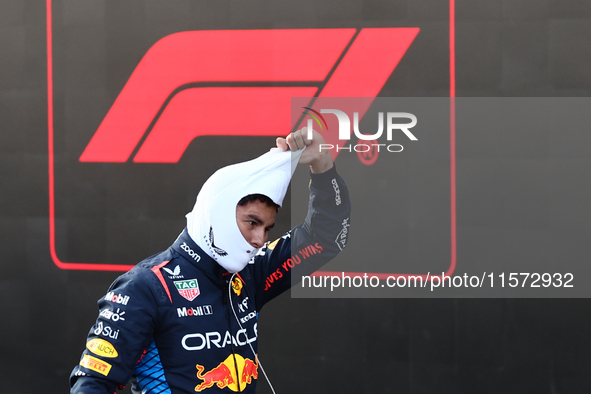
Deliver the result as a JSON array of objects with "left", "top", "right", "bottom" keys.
[{"left": 250, "top": 167, "right": 351, "bottom": 310}]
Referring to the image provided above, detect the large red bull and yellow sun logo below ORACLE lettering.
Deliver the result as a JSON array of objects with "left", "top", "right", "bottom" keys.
[{"left": 195, "top": 354, "right": 259, "bottom": 392}]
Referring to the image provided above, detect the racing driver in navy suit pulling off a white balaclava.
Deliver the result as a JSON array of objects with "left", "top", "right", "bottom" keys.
[{"left": 70, "top": 128, "right": 350, "bottom": 394}]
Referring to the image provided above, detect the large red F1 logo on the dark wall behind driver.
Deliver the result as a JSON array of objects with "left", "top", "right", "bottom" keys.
[{"left": 80, "top": 28, "right": 419, "bottom": 163}]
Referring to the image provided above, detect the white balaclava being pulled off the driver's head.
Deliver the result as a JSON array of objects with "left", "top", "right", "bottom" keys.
[{"left": 187, "top": 149, "right": 304, "bottom": 273}]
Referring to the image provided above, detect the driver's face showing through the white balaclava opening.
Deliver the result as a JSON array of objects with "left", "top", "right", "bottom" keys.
[{"left": 236, "top": 200, "right": 277, "bottom": 248}]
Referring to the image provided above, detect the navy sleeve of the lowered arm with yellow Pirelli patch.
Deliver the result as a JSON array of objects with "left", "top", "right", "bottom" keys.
[{"left": 70, "top": 267, "right": 157, "bottom": 394}]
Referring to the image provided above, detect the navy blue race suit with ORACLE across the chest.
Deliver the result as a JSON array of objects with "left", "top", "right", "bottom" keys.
[{"left": 70, "top": 168, "right": 350, "bottom": 394}]
